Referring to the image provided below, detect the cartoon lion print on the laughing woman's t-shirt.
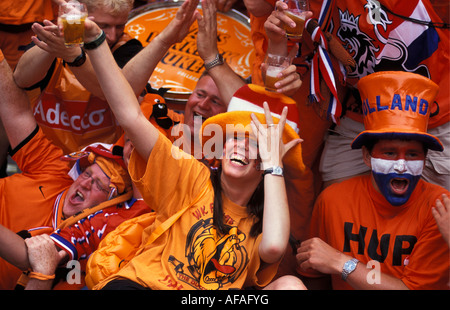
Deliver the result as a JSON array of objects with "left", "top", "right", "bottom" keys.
[{"left": 172, "top": 218, "right": 248, "bottom": 290}]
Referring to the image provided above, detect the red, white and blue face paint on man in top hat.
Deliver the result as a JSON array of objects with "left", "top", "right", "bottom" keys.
[{"left": 371, "top": 157, "right": 424, "bottom": 206}]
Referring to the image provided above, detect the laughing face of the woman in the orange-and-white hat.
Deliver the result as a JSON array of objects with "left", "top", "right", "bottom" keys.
[{"left": 222, "top": 136, "right": 262, "bottom": 182}]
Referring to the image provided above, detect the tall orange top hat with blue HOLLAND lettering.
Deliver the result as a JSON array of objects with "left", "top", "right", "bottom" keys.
[{"left": 351, "top": 71, "right": 444, "bottom": 151}]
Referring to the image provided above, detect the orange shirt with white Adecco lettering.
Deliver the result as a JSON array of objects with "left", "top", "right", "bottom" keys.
[{"left": 32, "top": 58, "right": 122, "bottom": 154}]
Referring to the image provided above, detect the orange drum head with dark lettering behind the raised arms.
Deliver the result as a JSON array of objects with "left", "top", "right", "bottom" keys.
[{"left": 125, "top": 2, "right": 254, "bottom": 100}]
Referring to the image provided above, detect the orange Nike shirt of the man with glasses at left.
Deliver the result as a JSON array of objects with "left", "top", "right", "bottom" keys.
[{"left": 0, "top": 127, "right": 73, "bottom": 289}]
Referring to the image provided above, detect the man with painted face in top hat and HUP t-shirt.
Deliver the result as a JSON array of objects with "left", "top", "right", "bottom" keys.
[{"left": 296, "top": 71, "right": 450, "bottom": 289}]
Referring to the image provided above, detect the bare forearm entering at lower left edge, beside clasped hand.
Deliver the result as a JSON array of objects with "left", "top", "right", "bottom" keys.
[{"left": 0, "top": 225, "right": 30, "bottom": 270}]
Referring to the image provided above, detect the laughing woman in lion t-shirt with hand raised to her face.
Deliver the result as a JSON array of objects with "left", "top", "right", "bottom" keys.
[{"left": 82, "top": 0, "right": 312, "bottom": 289}]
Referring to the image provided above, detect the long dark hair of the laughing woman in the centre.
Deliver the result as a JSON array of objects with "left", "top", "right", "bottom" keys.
[{"left": 210, "top": 165, "right": 264, "bottom": 237}]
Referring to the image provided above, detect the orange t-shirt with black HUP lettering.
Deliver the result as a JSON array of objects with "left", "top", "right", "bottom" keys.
[{"left": 311, "top": 176, "right": 450, "bottom": 289}]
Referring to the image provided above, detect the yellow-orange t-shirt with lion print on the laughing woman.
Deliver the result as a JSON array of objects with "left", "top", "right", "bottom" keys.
[{"left": 94, "top": 134, "right": 278, "bottom": 290}]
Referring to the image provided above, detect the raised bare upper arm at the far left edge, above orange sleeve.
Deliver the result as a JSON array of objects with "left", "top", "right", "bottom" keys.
[{"left": 0, "top": 50, "right": 36, "bottom": 149}]
